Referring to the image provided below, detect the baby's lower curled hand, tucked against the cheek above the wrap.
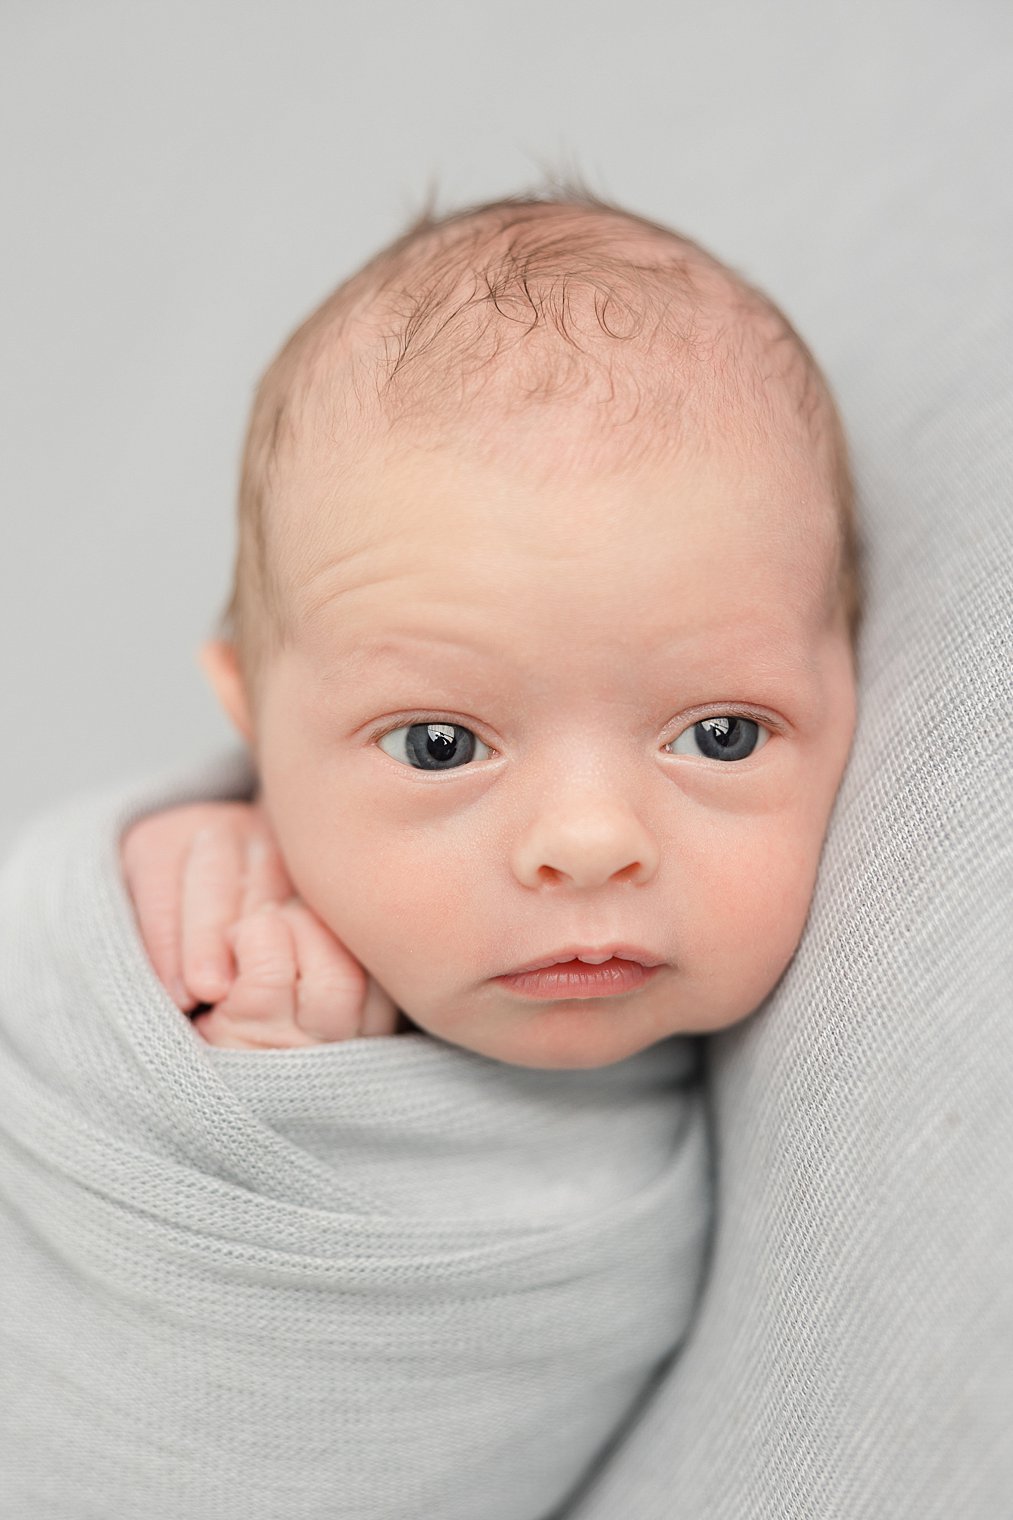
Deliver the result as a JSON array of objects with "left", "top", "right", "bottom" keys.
[{"left": 193, "top": 897, "right": 397, "bottom": 1050}]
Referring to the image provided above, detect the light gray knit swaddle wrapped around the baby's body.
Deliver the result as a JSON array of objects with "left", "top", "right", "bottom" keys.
[{"left": 0, "top": 754, "right": 709, "bottom": 1520}]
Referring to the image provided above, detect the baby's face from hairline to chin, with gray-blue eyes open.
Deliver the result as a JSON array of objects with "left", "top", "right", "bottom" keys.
[{"left": 231, "top": 407, "right": 855, "bottom": 1067}]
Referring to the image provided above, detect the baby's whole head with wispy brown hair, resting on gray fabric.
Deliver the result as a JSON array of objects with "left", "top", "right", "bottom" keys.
[{"left": 204, "top": 193, "right": 859, "bottom": 1067}]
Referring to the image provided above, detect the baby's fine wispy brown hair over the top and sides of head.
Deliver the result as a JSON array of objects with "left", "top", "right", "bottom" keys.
[{"left": 219, "top": 176, "right": 862, "bottom": 705}]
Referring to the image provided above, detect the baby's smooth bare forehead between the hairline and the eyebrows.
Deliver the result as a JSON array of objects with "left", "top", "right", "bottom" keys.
[{"left": 277, "top": 404, "right": 837, "bottom": 641}]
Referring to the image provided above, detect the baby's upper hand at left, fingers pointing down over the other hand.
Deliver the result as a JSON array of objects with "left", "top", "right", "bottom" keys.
[{"left": 120, "top": 803, "right": 294, "bottom": 1012}]
